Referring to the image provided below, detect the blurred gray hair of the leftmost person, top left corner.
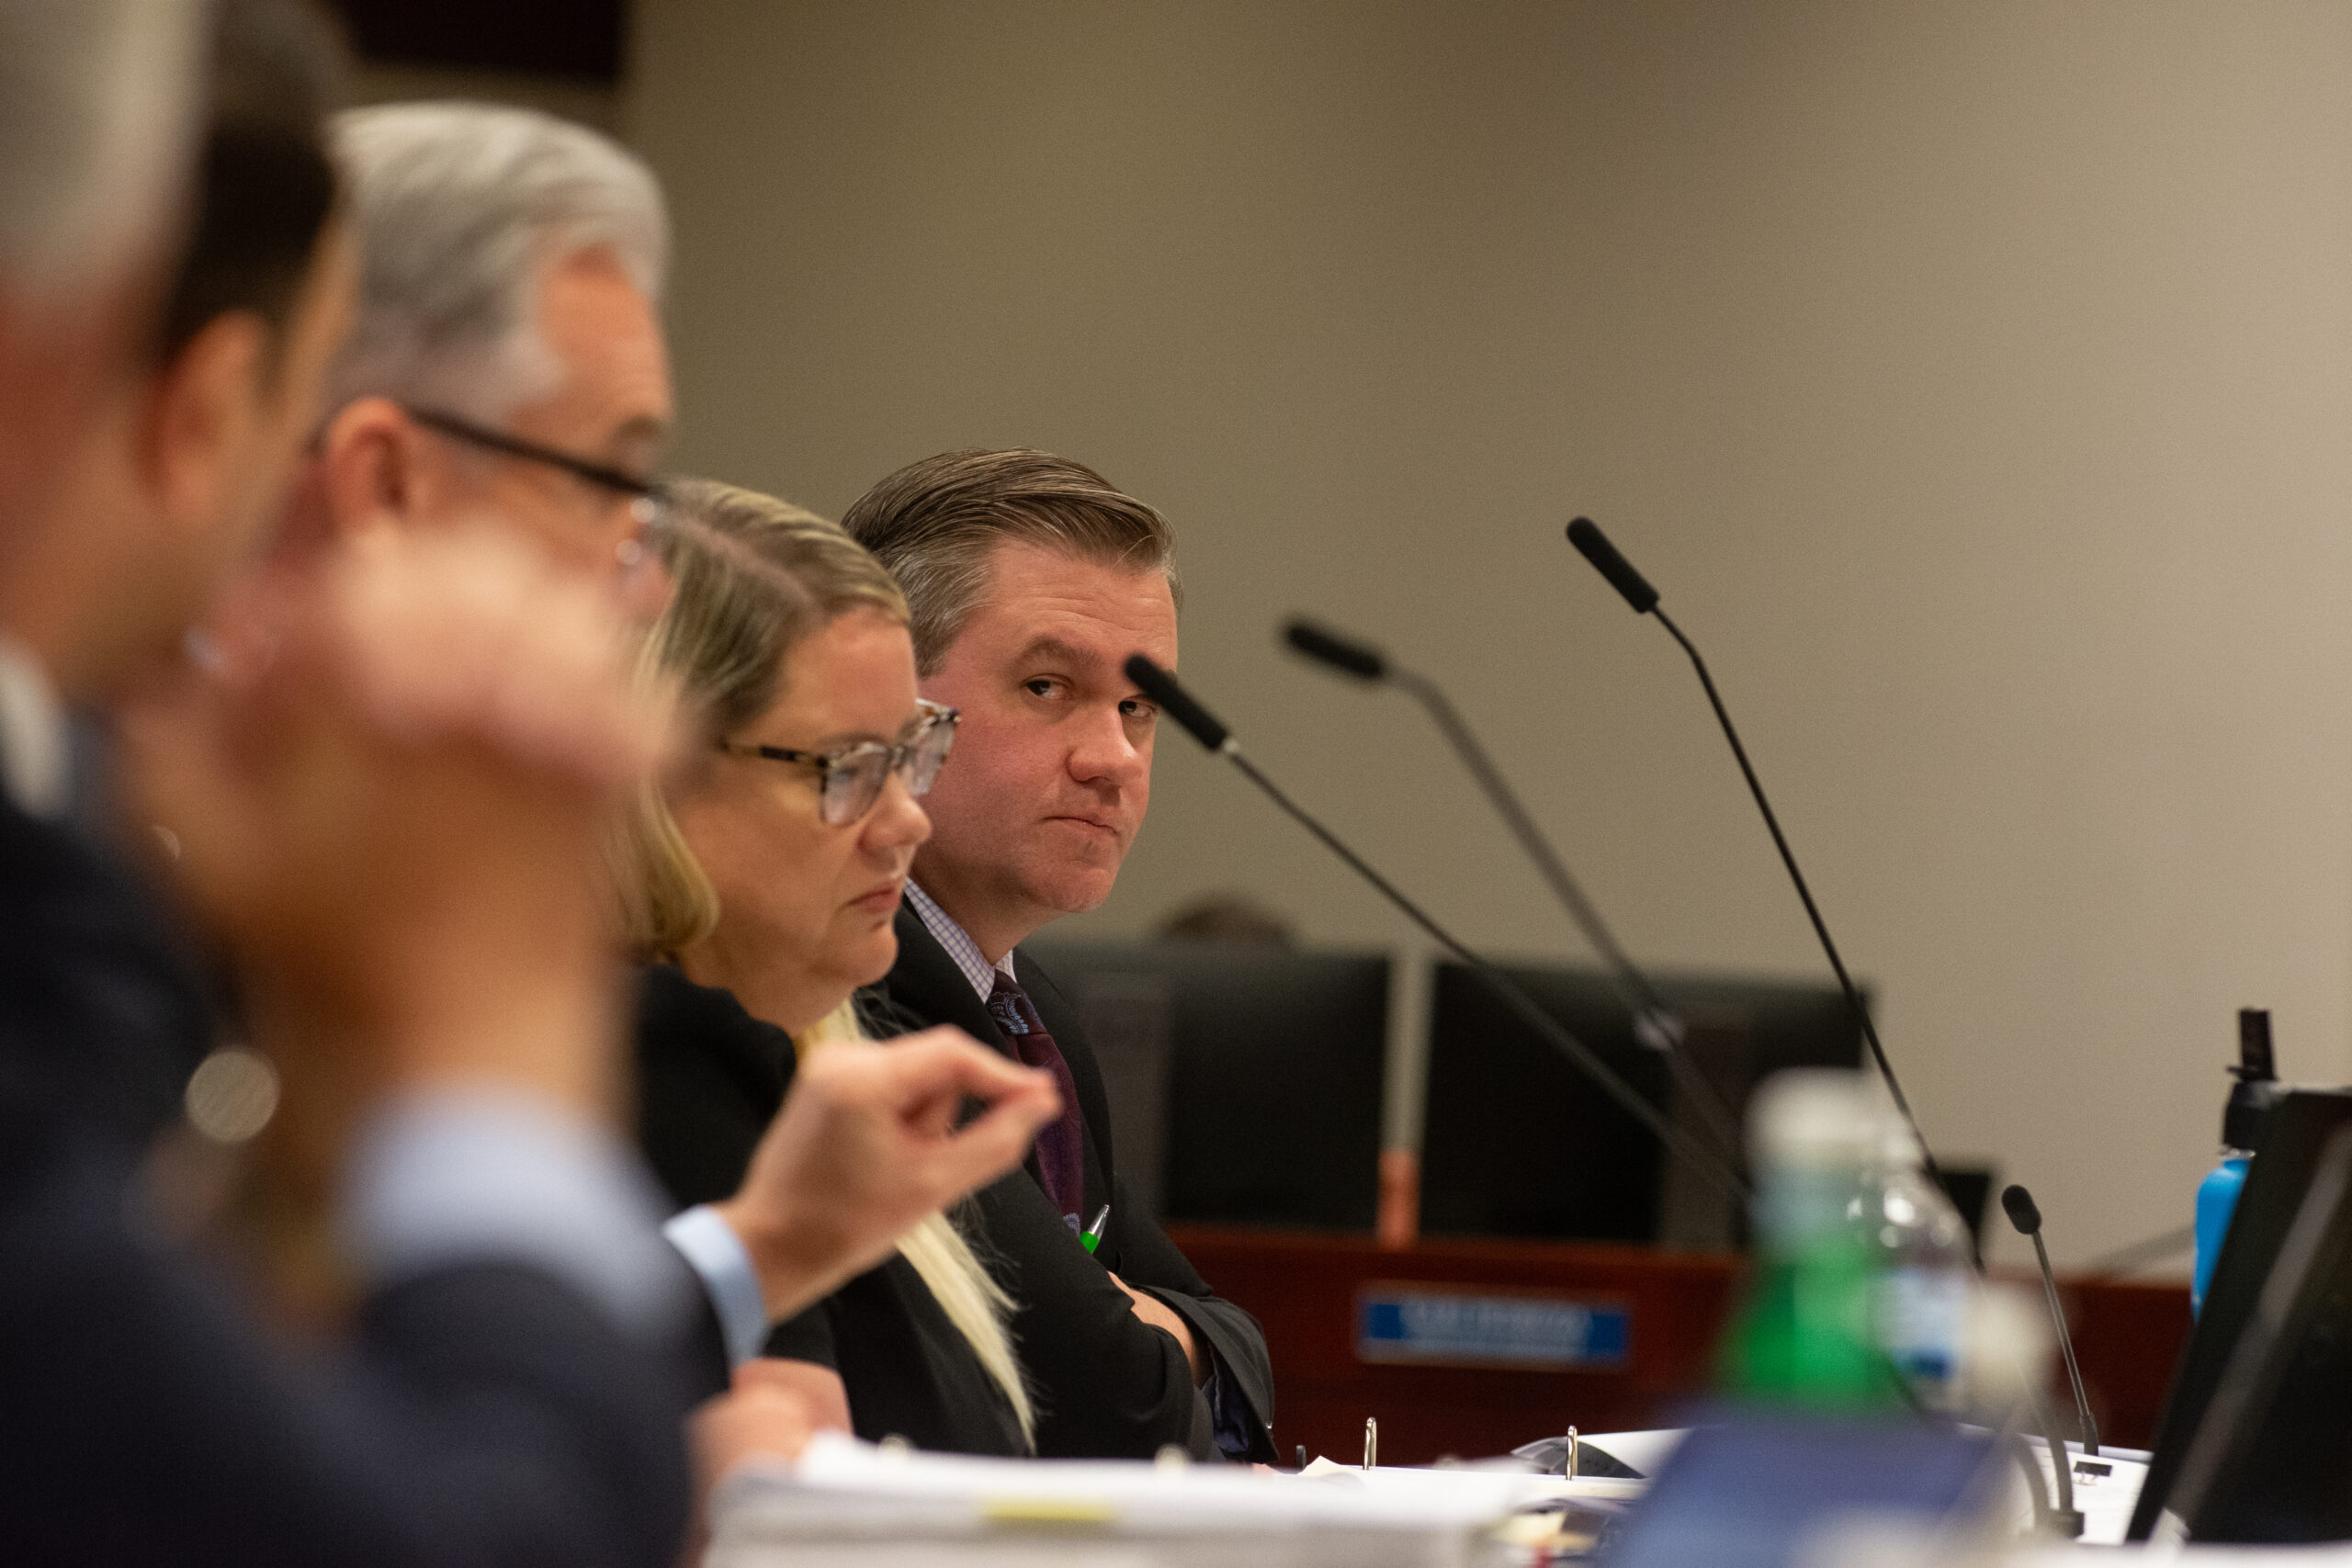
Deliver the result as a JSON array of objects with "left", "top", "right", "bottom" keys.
[{"left": 0, "top": 0, "right": 211, "bottom": 294}]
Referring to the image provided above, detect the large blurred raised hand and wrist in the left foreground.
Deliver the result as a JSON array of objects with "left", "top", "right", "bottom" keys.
[{"left": 122, "top": 526, "right": 668, "bottom": 1175}]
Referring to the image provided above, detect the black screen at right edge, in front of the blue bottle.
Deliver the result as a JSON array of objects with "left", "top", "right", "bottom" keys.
[{"left": 2129, "top": 1089, "right": 2352, "bottom": 1540}]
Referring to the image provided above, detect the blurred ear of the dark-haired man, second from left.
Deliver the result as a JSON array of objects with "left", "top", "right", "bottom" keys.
[{"left": 139, "top": 310, "right": 270, "bottom": 543}]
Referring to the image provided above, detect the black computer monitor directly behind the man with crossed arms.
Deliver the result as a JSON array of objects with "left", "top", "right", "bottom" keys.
[{"left": 1023, "top": 941, "right": 1390, "bottom": 1229}]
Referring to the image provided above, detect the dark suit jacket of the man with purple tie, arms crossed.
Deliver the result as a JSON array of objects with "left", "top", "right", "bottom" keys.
[{"left": 861, "top": 908, "right": 1275, "bottom": 1462}]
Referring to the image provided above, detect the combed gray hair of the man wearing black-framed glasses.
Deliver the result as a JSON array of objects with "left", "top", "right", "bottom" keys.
[{"left": 327, "top": 101, "right": 671, "bottom": 421}]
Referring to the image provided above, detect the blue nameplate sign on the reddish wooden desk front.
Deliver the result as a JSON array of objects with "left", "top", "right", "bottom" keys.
[{"left": 1355, "top": 1286, "right": 1633, "bottom": 1371}]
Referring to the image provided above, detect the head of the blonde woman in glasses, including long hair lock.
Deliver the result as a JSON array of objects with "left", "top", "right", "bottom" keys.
[{"left": 623, "top": 479, "right": 1035, "bottom": 1434}]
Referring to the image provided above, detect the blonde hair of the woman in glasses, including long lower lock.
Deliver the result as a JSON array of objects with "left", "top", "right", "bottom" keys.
[{"left": 618, "top": 479, "right": 1037, "bottom": 1443}]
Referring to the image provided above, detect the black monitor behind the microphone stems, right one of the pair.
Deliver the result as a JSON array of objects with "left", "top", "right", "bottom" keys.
[{"left": 1420, "top": 964, "right": 1863, "bottom": 1248}]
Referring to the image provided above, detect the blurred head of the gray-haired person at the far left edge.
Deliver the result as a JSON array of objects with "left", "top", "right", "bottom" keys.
[{"left": 0, "top": 0, "right": 205, "bottom": 602}]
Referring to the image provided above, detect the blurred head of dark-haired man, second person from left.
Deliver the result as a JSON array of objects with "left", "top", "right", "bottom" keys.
[{"left": 14, "top": 0, "right": 350, "bottom": 698}]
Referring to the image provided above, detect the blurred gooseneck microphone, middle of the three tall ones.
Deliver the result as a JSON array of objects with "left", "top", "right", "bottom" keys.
[{"left": 1282, "top": 618, "right": 1740, "bottom": 1170}]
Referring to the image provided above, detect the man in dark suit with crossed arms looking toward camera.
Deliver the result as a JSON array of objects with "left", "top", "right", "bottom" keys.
[{"left": 842, "top": 451, "right": 1275, "bottom": 1460}]
